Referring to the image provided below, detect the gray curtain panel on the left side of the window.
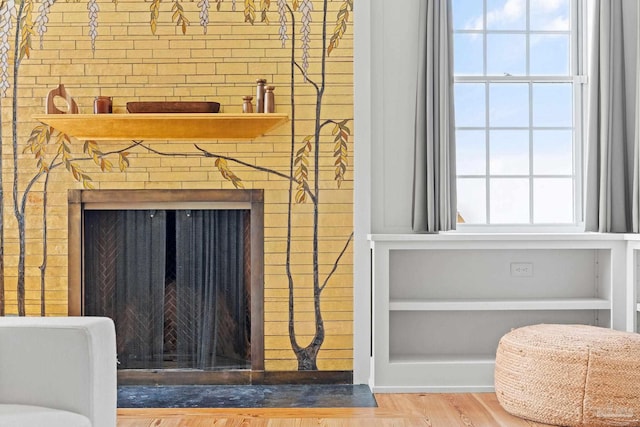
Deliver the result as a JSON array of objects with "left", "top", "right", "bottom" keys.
[{"left": 412, "top": 0, "right": 457, "bottom": 233}]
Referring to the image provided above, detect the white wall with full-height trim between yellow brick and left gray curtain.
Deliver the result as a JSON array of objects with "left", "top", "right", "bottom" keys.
[{"left": 354, "top": 0, "right": 421, "bottom": 384}]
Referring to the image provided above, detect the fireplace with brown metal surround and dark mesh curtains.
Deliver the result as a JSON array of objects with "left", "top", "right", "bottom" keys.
[{"left": 69, "top": 190, "right": 264, "bottom": 384}]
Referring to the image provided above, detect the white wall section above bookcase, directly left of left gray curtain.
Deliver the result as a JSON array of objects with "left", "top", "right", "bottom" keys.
[{"left": 371, "top": 0, "right": 421, "bottom": 233}]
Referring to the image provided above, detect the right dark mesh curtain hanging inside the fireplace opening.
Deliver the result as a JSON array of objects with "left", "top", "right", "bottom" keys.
[{"left": 176, "top": 210, "right": 249, "bottom": 369}]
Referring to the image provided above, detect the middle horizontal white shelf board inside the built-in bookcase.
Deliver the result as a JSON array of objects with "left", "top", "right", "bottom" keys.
[{"left": 389, "top": 298, "right": 612, "bottom": 311}]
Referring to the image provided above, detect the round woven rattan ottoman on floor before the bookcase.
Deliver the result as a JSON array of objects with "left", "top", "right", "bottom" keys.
[{"left": 495, "top": 325, "right": 640, "bottom": 427}]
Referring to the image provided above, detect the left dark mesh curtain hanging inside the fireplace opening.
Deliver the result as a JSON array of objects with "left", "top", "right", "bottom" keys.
[{"left": 84, "top": 210, "right": 166, "bottom": 369}]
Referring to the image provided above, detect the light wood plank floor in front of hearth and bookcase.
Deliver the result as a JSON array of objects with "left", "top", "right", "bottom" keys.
[{"left": 118, "top": 393, "right": 546, "bottom": 427}]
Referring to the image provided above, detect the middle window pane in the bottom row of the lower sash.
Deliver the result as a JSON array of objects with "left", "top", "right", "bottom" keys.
[{"left": 490, "top": 178, "right": 529, "bottom": 224}]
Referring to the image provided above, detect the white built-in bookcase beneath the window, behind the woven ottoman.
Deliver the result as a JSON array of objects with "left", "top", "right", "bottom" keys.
[{"left": 370, "top": 234, "right": 626, "bottom": 392}]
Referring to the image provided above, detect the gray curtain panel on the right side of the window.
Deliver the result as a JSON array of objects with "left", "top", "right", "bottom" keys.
[{"left": 585, "top": 0, "right": 640, "bottom": 233}]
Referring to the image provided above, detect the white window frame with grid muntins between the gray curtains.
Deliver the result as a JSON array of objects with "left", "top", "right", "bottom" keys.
[{"left": 454, "top": 0, "right": 587, "bottom": 233}]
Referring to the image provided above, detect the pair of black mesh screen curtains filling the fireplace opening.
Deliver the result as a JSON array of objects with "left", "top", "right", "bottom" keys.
[{"left": 84, "top": 210, "right": 251, "bottom": 370}]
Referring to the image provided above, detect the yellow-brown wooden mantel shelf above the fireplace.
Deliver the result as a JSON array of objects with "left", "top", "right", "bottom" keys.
[{"left": 33, "top": 113, "right": 289, "bottom": 141}]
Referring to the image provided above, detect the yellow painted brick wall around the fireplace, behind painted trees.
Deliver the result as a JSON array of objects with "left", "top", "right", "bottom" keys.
[{"left": 2, "top": 0, "right": 354, "bottom": 370}]
